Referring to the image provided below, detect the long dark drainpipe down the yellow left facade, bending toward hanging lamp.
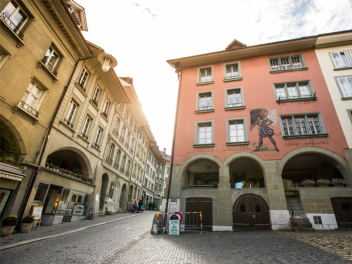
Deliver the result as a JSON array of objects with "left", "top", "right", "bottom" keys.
[{"left": 17, "top": 56, "right": 97, "bottom": 228}]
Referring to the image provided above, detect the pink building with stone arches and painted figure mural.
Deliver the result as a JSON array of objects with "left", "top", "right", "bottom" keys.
[{"left": 168, "top": 32, "right": 352, "bottom": 231}]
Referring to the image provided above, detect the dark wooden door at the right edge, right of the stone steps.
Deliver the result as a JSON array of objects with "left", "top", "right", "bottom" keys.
[{"left": 331, "top": 197, "right": 352, "bottom": 228}]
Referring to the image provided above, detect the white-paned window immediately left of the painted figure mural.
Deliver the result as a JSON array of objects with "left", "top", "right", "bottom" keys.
[{"left": 226, "top": 117, "right": 249, "bottom": 146}]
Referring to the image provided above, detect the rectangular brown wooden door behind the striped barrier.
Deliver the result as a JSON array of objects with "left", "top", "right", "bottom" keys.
[{"left": 185, "top": 197, "right": 213, "bottom": 231}]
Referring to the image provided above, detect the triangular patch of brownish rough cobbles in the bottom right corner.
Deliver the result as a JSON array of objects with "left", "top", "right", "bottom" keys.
[{"left": 279, "top": 231, "right": 352, "bottom": 260}]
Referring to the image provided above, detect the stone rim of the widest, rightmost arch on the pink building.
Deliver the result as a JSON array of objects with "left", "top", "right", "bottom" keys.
[{"left": 280, "top": 147, "right": 352, "bottom": 182}]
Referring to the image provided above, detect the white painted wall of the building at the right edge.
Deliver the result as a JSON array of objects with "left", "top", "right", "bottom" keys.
[{"left": 315, "top": 45, "right": 352, "bottom": 148}]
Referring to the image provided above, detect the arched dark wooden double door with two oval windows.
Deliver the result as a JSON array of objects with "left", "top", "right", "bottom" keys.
[{"left": 233, "top": 194, "right": 271, "bottom": 230}]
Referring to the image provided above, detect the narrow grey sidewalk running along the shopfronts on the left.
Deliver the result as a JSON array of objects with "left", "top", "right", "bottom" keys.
[{"left": 0, "top": 211, "right": 153, "bottom": 247}]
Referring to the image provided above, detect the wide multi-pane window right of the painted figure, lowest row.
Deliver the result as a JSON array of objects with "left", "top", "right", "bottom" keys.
[{"left": 280, "top": 113, "right": 328, "bottom": 138}]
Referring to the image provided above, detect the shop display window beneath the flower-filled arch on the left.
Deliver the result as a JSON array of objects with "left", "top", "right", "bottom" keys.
[{"left": 56, "top": 189, "right": 90, "bottom": 215}]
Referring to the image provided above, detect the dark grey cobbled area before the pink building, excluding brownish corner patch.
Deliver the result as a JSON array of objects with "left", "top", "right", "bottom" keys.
[{"left": 108, "top": 231, "right": 351, "bottom": 264}]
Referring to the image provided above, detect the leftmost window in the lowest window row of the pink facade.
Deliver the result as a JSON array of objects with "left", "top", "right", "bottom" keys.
[{"left": 193, "top": 120, "right": 215, "bottom": 148}]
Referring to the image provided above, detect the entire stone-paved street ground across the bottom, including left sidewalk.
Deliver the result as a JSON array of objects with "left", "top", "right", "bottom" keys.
[{"left": 0, "top": 213, "right": 352, "bottom": 264}]
